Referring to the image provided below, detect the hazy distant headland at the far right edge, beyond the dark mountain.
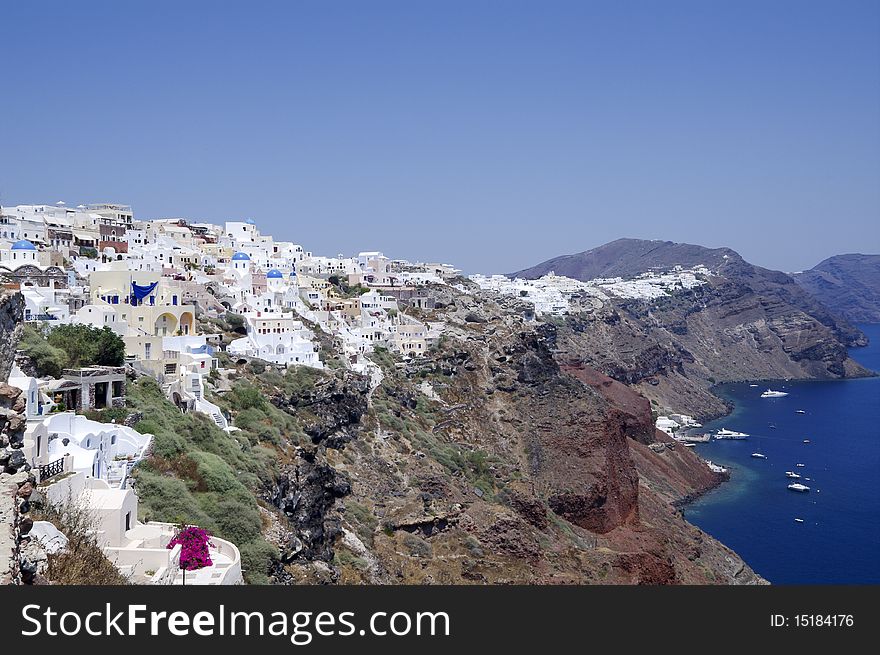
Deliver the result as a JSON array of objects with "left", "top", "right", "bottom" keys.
[{"left": 792, "top": 254, "right": 880, "bottom": 323}]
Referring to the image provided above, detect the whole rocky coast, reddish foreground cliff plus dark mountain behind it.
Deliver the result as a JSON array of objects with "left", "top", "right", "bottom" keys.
[{"left": 254, "top": 240, "right": 866, "bottom": 584}]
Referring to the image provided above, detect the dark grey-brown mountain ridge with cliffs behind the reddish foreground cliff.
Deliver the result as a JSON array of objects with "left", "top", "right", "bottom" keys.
[{"left": 517, "top": 239, "right": 868, "bottom": 417}]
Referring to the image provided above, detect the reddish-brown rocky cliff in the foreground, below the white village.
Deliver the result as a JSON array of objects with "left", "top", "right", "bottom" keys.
[{"left": 249, "top": 288, "right": 761, "bottom": 584}]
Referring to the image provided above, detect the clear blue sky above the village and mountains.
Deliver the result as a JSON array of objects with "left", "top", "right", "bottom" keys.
[{"left": 0, "top": 0, "right": 880, "bottom": 272}]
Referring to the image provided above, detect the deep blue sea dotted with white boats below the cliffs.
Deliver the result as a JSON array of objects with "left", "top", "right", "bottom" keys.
[{"left": 685, "top": 325, "right": 880, "bottom": 584}]
